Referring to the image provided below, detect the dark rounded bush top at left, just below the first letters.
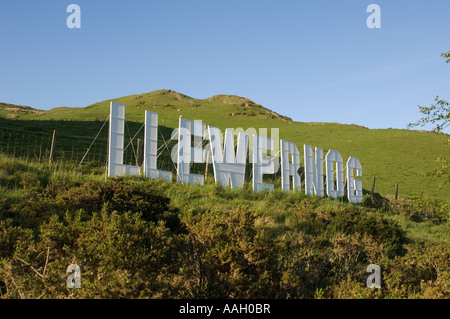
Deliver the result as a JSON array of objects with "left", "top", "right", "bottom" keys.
[{"left": 8, "top": 179, "right": 179, "bottom": 230}]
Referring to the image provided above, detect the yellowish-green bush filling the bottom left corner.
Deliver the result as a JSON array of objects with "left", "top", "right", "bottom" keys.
[{"left": 0, "top": 210, "right": 173, "bottom": 298}]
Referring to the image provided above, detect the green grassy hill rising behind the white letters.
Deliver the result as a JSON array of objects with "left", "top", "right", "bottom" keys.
[{"left": 0, "top": 90, "right": 450, "bottom": 199}]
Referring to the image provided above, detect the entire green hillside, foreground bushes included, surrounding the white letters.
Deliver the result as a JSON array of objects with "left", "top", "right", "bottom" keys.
[{"left": 0, "top": 90, "right": 450, "bottom": 300}]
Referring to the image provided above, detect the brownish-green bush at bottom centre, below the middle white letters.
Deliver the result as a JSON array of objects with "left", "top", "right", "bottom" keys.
[{"left": 173, "top": 207, "right": 278, "bottom": 298}]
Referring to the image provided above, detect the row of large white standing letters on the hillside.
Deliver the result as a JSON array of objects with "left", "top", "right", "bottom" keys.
[{"left": 108, "top": 102, "right": 363, "bottom": 203}]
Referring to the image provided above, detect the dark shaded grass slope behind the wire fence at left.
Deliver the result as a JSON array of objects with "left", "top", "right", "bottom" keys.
[{"left": 0, "top": 119, "right": 202, "bottom": 178}]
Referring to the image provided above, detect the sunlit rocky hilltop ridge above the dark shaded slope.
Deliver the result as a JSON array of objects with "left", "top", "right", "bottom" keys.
[{"left": 0, "top": 90, "right": 292, "bottom": 125}]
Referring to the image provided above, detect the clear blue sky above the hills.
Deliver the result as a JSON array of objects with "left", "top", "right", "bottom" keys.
[{"left": 0, "top": 0, "right": 450, "bottom": 132}]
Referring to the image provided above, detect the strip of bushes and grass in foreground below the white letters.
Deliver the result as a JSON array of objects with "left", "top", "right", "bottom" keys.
[{"left": 0, "top": 156, "right": 450, "bottom": 298}]
